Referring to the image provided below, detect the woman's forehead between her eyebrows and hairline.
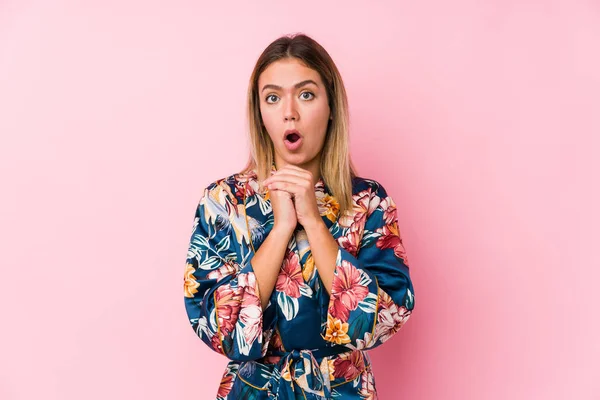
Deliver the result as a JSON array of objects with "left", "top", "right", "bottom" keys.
[{"left": 258, "top": 58, "right": 323, "bottom": 90}]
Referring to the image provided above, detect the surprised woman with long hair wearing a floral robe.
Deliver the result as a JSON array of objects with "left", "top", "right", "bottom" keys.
[{"left": 184, "top": 34, "right": 414, "bottom": 399}]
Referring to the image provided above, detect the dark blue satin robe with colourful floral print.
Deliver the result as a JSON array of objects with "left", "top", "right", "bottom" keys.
[{"left": 183, "top": 167, "right": 414, "bottom": 400}]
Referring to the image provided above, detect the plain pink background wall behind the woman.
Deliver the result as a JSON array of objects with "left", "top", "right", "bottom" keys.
[{"left": 0, "top": 0, "right": 600, "bottom": 400}]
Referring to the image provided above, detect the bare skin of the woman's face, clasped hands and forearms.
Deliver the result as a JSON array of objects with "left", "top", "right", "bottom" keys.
[{"left": 251, "top": 58, "right": 339, "bottom": 309}]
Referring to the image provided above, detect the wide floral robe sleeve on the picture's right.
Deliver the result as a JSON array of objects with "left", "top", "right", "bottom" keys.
[{"left": 321, "top": 184, "right": 414, "bottom": 349}]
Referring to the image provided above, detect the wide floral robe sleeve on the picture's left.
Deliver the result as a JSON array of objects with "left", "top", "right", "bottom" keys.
[{"left": 184, "top": 184, "right": 274, "bottom": 361}]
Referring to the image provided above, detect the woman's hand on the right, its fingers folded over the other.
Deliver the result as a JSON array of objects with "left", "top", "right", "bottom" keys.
[{"left": 263, "top": 165, "right": 322, "bottom": 229}]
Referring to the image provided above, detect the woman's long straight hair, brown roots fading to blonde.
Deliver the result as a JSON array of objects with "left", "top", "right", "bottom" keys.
[{"left": 243, "top": 33, "right": 357, "bottom": 215}]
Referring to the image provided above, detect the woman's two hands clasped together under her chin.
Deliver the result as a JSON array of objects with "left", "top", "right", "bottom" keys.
[{"left": 262, "top": 165, "right": 322, "bottom": 231}]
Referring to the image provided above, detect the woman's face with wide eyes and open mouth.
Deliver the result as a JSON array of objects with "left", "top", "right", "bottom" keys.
[{"left": 258, "top": 58, "right": 330, "bottom": 172}]
